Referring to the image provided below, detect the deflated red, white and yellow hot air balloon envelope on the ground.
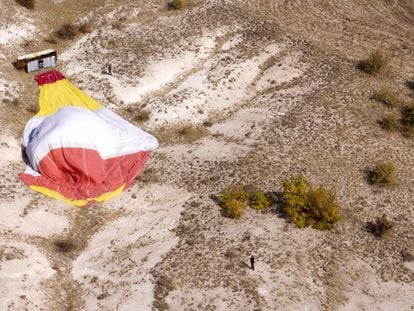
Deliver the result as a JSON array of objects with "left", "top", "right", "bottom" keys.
[{"left": 20, "top": 70, "right": 158, "bottom": 206}]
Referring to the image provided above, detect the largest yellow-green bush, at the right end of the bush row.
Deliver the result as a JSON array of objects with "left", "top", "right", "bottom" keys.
[{"left": 282, "top": 176, "right": 340, "bottom": 230}]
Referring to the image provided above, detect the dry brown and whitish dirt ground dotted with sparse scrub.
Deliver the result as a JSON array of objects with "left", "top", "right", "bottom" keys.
[{"left": 0, "top": 0, "right": 414, "bottom": 311}]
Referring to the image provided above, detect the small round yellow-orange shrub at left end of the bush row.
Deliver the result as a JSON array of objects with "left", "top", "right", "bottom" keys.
[{"left": 218, "top": 185, "right": 249, "bottom": 218}]
